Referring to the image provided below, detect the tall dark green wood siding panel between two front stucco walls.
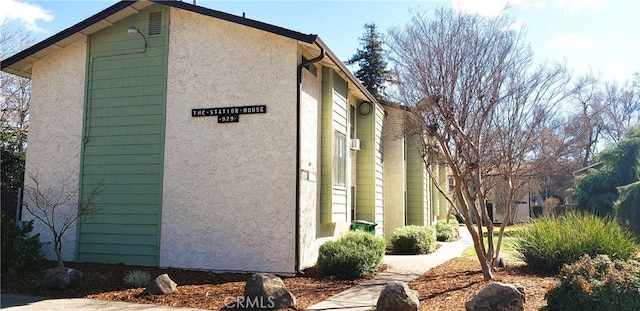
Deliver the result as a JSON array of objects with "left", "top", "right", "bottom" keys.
[{"left": 78, "top": 5, "right": 168, "bottom": 266}]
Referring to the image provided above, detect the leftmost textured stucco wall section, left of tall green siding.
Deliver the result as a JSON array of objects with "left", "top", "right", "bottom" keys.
[{"left": 23, "top": 40, "right": 86, "bottom": 261}]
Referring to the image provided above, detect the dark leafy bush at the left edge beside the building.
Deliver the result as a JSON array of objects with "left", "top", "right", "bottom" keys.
[{"left": 0, "top": 213, "right": 43, "bottom": 273}]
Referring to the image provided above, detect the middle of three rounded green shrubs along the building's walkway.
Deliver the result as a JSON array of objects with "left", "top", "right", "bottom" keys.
[{"left": 391, "top": 225, "right": 436, "bottom": 254}]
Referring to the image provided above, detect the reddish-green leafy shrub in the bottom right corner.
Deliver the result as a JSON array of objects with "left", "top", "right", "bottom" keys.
[{"left": 546, "top": 255, "right": 640, "bottom": 311}]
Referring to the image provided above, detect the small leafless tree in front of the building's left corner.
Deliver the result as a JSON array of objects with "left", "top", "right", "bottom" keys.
[{"left": 23, "top": 174, "right": 103, "bottom": 267}]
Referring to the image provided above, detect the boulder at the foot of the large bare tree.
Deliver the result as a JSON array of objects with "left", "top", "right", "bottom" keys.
[{"left": 464, "top": 282, "right": 525, "bottom": 311}]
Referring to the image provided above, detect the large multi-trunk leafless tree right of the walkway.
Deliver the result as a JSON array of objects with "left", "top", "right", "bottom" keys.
[{"left": 390, "top": 9, "right": 569, "bottom": 280}]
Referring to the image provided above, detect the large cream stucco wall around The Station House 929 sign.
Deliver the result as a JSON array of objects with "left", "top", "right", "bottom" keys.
[{"left": 160, "top": 9, "right": 297, "bottom": 273}]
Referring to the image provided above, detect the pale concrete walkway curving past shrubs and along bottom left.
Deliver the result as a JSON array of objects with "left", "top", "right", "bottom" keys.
[{"left": 0, "top": 226, "right": 473, "bottom": 311}]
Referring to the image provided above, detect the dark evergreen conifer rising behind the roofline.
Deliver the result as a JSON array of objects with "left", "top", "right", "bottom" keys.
[{"left": 346, "top": 23, "right": 391, "bottom": 100}]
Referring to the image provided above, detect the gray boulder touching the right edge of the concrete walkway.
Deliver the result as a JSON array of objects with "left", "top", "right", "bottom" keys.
[{"left": 376, "top": 281, "right": 420, "bottom": 311}]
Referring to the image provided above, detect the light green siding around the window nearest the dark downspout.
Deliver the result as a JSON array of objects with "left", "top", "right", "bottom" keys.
[{"left": 320, "top": 67, "right": 349, "bottom": 223}]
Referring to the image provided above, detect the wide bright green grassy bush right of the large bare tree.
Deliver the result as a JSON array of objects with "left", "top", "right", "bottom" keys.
[{"left": 513, "top": 213, "right": 638, "bottom": 272}]
